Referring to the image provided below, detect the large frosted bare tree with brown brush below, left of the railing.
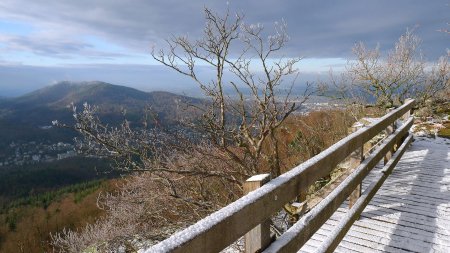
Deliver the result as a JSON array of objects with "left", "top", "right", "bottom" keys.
[{"left": 53, "top": 8, "right": 309, "bottom": 251}]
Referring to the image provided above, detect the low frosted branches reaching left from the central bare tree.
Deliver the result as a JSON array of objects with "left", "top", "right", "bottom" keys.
[{"left": 60, "top": 104, "right": 242, "bottom": 201}]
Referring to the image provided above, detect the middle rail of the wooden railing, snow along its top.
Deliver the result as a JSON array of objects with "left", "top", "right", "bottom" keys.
[{"left": 264, "top": 118, "right": 413, "bottom": 253}]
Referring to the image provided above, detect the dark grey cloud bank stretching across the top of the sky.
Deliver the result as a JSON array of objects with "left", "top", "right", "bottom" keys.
[{"left": 0, "top": 0, "right": 450, "bottom": 60}]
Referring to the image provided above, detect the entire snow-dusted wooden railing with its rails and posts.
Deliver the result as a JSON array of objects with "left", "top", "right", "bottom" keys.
[{"left": 140, "top": 100, "right": 414, "bottom": 253}]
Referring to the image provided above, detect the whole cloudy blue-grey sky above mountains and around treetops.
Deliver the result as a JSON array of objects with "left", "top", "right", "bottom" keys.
[{"left": 0, "top": 0, "right": 450, "bottom": 97}]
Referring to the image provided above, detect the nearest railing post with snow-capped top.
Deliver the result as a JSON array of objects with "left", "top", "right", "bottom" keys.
[{"left": 244, "top": 174, "right": 272, "bottom": 253}]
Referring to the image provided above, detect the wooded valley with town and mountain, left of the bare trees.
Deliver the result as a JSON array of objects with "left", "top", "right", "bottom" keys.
[{"left": 0, "top": 82, "right": 336, "bottom": 252}]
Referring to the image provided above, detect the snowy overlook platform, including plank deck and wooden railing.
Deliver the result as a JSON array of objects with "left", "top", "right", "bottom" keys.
[{"left": 145, "top": 99, "right": 450, "bottom": 253}]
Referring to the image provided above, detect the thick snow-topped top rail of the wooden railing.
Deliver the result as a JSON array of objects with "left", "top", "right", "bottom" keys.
[{"left": 140, "top": 100, "right": 414, "bottom": 253}]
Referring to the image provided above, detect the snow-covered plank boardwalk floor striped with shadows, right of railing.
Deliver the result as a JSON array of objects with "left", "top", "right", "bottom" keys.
[{"left": 300, "top": 137, "right": 450, "bottom": 252}]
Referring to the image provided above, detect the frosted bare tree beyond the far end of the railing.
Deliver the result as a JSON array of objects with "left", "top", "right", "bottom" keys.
[{"left": 348, "top": 30, "right": 425, "bottom": 107}]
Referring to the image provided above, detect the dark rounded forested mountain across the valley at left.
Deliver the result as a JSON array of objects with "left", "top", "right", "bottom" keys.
[{"left": 0, "top": 81, "right": 201, "bottom": 146}]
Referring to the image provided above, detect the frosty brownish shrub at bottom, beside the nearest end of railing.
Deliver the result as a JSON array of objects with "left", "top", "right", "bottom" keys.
[{"left": 51, "top": 172, "right": 236, "bottom": 252}]
